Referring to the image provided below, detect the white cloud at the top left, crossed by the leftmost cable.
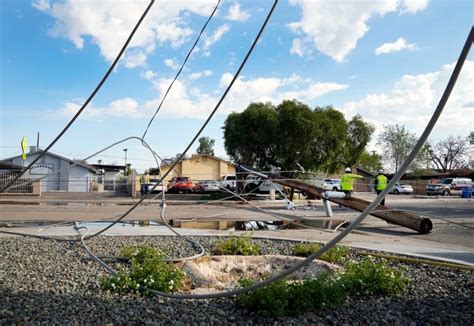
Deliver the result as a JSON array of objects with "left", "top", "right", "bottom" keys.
[{"left": 32, "top": 0, "right": 215, "bottom": 67}]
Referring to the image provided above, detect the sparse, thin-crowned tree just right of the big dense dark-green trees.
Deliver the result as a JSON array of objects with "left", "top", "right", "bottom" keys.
[{"left": 377, "top": 124, "right": 416, "bottom": 172}]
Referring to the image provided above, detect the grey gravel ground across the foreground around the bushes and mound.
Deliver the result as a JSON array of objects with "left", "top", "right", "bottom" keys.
[{"left": 0, "top": 237, "right": 474, "bottom": 325}]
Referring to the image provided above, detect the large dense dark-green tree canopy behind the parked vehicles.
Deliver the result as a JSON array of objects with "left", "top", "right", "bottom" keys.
[{"left": 223, "top": 100, "right": 374, "bottom": 172}]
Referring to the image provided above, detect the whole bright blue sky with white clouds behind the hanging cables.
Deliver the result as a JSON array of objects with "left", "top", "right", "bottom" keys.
[{"left": 0, "top": 0, "right": 474, "bottom": 171}]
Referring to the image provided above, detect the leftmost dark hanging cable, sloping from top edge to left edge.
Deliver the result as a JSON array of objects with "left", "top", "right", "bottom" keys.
[{"left": 0, "top": 0, "right": 155, "bottom": 193}]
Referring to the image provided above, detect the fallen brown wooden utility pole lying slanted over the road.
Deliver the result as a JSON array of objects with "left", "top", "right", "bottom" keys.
[{"left": 240, "top": 166, "right": 433, "bottom": 234}]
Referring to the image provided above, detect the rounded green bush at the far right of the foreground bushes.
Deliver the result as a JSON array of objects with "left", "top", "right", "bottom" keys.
[{"left": 341, "top": 256, "right": 408, "bottom": 295}]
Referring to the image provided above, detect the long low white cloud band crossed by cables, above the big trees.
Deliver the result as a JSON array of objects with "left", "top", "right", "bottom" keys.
[{"left": 56, "top": 71, "right": 348, "bottom": 121}]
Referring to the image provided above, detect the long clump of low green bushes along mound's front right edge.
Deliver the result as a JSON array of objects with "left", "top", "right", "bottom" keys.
[{"left": 237, "top": 258, "right": 408, "bottom": 317}]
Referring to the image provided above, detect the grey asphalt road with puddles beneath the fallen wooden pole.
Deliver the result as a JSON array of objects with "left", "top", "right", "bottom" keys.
[{"left": 0, "top": 193, "right": 474, "bottom": 244}]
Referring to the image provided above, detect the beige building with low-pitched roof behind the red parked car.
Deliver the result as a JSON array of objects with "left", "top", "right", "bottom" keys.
[{"left": 156, "top": 154, "right": 235, "bottom": 181}]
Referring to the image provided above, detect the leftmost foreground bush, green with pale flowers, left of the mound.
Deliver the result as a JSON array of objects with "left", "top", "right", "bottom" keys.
[{"left": 100, "top": 246, "right": 186, "bottom": 294}]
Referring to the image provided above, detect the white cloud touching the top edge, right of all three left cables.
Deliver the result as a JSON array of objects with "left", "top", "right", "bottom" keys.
[{"left": 288, "top": 0, "right": 428, "bottom": 62}]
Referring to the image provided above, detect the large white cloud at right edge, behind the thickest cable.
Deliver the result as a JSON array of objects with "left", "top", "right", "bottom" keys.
[{"left": 341, "top": 61, "right": 474, "bottom": 138}]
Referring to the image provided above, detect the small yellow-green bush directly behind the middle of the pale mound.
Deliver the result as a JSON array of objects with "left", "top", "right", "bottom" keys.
[{"left": 212, "top": 234, "right": 260, "bottom": 256}]
